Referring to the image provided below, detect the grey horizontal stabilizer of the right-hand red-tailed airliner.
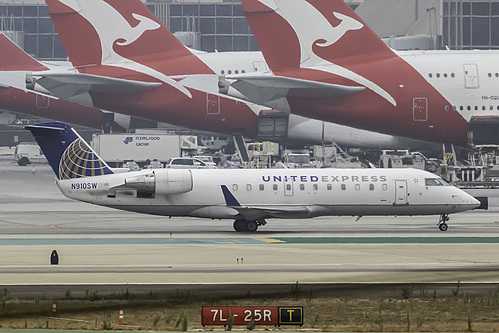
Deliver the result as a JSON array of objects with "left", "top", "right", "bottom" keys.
[{"left": 219, "top": 73, "right": 365, "bottom": 107}]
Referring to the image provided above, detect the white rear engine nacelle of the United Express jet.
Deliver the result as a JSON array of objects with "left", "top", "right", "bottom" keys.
[{"left": 125, "top": 169, "right": 192, "bottom": 195}]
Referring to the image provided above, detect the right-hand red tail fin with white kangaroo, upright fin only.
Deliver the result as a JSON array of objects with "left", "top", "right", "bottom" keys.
[{"left": 241, "top": 0, "right": 395, "bottom": 70}]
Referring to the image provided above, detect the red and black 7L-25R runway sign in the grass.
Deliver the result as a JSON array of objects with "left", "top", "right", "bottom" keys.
[{"left": 201, "top": 306, "right": 303, "bottom": 326}]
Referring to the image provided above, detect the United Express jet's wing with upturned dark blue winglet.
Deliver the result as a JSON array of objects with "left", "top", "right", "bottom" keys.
[{"left": 222, "top": 185, "right": 310, "bottom": 220}]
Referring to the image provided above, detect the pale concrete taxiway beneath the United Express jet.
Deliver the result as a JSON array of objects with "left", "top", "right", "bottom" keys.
[{"left": 0, "top": 158, "right": 499, "bottom": 285}]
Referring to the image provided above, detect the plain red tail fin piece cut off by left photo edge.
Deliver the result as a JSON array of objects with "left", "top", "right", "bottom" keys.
[{"left": 0, "top": 33, "right": 47, "bottom": 71}]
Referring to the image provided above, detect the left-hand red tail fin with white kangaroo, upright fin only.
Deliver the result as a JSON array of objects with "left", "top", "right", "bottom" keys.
[{"left": 46, "top": 0, "right": 206, "bottom": 75}]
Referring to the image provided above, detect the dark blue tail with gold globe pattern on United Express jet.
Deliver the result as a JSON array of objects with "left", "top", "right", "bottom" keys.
[{"left": 25, "top": 122, "right": 113, "bottom": 180}]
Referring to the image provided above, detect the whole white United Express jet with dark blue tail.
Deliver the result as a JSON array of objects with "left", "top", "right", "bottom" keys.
[{"left": 26, "top": 122, "right": 480, "bottom": 231}]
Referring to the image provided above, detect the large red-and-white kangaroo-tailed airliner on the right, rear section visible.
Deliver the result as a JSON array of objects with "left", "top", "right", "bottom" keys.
[{"left": 221, "top": 0, "right": 499, "bottom": 146}]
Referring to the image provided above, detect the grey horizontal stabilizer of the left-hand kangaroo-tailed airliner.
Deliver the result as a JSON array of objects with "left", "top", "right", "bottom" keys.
[{"left": 27, "top": 72, "right": 161, "bottom": 100}]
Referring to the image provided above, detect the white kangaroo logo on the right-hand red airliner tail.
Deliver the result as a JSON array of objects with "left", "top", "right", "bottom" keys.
[{"left": 258, "top": 0, "right": 397, "bottom": 106}]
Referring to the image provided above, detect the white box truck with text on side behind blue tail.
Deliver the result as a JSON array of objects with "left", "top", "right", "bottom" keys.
[{"left": 92, "top": 133, "right": 198, "bottom": 167}]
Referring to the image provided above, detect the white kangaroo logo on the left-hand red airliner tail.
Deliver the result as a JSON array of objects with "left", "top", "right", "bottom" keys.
[{"left": 59, "top": 0, "right": 192, "bottom": 98}]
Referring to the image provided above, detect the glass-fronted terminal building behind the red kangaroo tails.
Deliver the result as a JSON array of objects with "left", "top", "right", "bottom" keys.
[{"left": 0, "top": 0, "right": 499, "bottom": 60}]
